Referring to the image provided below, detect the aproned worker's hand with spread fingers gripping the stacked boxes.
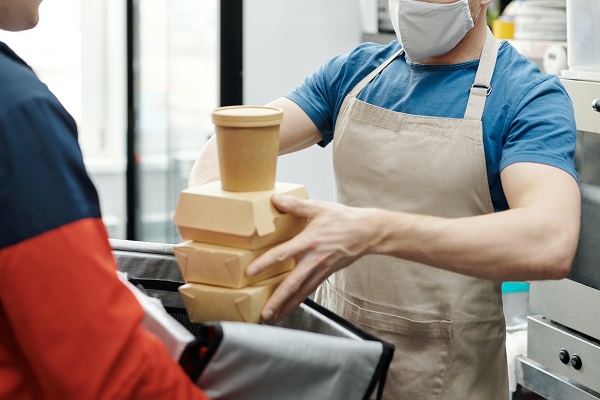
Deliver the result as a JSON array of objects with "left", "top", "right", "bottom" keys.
[{"left": 246, "top": 194, "right": 379, "bottom": 319}]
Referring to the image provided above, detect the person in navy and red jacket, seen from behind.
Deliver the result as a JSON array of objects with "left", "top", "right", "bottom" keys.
[{"left": 0, "top": 0, "right": 207, "bottom": 400}]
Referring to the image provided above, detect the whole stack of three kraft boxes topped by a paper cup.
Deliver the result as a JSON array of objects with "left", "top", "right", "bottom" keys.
[{"left": 174, "top": 106, "right": 308, "bottom": 322}]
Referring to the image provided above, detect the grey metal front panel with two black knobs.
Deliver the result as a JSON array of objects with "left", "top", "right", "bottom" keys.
[{"left": 527, "top": 316, "right": 600, "bottom": 392}]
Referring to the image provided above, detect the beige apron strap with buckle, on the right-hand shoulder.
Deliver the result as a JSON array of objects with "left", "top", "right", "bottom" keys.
[{"left": 465, "top": 28, "right": 498, "bottom": 121}]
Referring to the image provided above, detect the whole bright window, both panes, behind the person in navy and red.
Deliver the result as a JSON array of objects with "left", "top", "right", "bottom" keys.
[{"left": 0, "top": 0, "right": 219, "bottom": 242}]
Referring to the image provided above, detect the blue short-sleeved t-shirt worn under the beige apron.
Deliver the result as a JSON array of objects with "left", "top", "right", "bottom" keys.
[{"left": 286, "top": 40, "right": 577, "bottom": 211}]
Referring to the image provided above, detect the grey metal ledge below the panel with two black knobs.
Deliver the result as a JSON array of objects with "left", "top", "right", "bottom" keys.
[{"left": 515, "top": 356, "right": 600, "bottom": 400}]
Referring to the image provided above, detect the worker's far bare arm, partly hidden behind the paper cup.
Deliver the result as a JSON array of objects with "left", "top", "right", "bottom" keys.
[{"left": 188, "top": 97, "right": 321, "bottom": 187}]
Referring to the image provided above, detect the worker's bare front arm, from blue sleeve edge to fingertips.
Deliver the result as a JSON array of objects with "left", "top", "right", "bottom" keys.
[{"left": 248, "top": 163, "right": 580, "bottom": 319}]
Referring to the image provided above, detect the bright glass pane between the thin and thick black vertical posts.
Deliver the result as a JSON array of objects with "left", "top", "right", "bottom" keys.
[{"left": 135, "top": 0, "right": 219, "bottom": 243}]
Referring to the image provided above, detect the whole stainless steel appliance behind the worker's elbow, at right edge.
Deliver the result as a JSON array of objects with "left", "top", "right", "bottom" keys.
[{"left": 513, "top": 79, "right": 600, "bottom": 400}]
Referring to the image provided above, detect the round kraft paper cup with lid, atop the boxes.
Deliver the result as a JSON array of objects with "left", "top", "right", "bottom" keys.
[{"left": 212, "top": 106, "right": 283, "bottom": 192}]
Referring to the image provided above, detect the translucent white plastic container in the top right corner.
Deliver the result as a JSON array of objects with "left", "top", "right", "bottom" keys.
[{"left": 567, "top": 0, "right": 600, "bottom": 75}]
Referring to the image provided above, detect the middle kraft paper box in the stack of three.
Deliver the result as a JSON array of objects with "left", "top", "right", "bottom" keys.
[{"left": 173, "top": 241, "right": 294, "bottom": 289}]
